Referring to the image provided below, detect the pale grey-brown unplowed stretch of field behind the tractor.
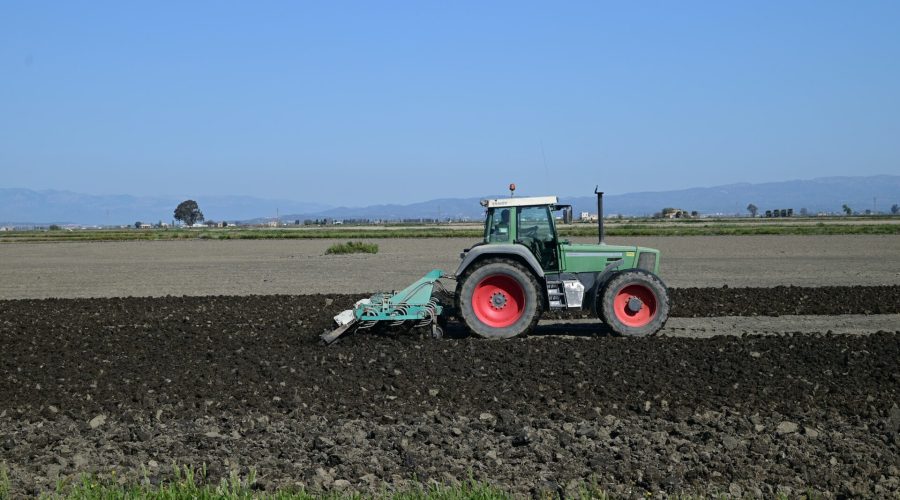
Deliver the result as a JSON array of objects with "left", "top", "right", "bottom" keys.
[{"left": 0, "top": 235, "right": 900, "bottom": 299}]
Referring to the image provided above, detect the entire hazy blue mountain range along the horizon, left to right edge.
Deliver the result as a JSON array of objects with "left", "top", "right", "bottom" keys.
[{"left": 0, "top": 175, "right": 900, "bottom": 225}]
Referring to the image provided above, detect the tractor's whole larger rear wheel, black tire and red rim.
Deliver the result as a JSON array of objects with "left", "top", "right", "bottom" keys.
[{"left": 456, "top": 259, "right": 543, "bottom": 339}]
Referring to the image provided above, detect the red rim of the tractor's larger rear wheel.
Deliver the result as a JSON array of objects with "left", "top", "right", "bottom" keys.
[{"left": 472, "top": 274, "right": 525, "bottom": 328}]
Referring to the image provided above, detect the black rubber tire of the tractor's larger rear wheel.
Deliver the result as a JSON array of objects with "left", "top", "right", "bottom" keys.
[{"left": 456, "top": 258, "right": 543, "bottom": 339}]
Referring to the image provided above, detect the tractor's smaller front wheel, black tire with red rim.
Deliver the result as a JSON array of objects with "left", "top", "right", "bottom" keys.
[{"left": 597, "top": 269, "right": 669, "bottom": 337}]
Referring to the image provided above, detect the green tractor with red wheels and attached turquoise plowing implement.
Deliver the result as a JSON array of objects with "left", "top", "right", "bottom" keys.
[{"left": 322, "top": 185, "right": 669, "bottom": 343}]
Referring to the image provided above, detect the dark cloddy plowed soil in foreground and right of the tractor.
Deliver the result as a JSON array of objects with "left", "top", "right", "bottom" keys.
[{"left": 0, "top": 286, "right": 900, "bottom": 497}]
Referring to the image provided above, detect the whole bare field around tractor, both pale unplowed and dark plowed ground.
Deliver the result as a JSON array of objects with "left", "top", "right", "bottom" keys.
[{"left": 0, "top": 235, "right": 900, "bottom": 497}]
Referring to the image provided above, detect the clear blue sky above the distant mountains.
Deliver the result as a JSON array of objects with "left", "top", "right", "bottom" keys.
[{"left": 0, "top": 0, "right": 900, "bottom": 205}]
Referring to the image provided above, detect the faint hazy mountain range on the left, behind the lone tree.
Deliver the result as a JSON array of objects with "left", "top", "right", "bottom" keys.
[{"left": 0, "top": 189, "right": 329, "bottom": 225}]
